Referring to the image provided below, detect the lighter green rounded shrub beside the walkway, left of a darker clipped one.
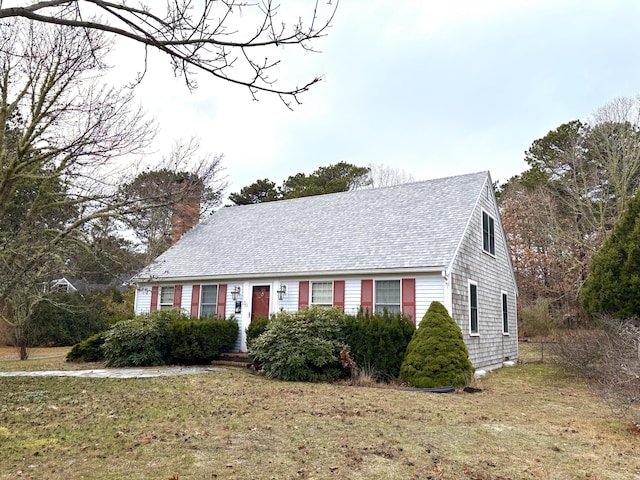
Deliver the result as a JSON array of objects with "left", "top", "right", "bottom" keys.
[{"left": 102, "top": 309, "right": 189, "bottom": 367}]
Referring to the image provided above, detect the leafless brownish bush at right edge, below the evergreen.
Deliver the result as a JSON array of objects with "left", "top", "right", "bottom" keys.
[{"left": 557, "top": 317, "right": 640, "bottom": 415}]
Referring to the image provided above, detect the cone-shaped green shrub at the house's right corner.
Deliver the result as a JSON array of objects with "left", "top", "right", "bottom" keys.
[{"left": 400, "top": 302, "right": 473, "bottom": 388}]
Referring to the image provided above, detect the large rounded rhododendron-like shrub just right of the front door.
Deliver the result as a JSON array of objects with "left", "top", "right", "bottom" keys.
[{"left": 249, "top": 307, "right": 346, "bottom": 381}]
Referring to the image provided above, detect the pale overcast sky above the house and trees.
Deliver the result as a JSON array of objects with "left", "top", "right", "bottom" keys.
[{"left": 107, "top": 0, "right": 640, "bottom": 192}]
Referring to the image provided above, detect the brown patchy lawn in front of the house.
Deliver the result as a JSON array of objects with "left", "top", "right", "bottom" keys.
[{"left": 0, "top": 344, "right": 640, "bottom": 480}]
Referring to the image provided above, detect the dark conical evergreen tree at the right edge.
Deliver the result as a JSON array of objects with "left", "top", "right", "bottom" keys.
[{"left": 581, "top": 191, "right": 640, "bottom": 319}]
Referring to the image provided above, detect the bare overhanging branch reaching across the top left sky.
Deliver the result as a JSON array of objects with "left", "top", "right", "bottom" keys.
[{"left": 0, "top": 0, "right": 338, "bottom": 105}]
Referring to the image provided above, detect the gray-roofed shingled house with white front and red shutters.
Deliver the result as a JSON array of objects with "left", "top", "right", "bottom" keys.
[{"left": 133, "top": 172, "right": 518, "bottom": 369}]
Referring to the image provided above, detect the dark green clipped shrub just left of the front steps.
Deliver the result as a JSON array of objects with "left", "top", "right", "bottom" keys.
[{"left": 168, "top": 318, "right": 239, "bottom": 365}]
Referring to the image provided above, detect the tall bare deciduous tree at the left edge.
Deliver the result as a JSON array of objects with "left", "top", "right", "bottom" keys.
[{"left": 0, "top": 20, "right": 155, "bottom": 358}]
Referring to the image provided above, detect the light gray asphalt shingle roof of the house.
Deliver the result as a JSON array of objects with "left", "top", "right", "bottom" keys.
[{"left": 134, "top": 172, "right": 490, "bottom": 281}]
